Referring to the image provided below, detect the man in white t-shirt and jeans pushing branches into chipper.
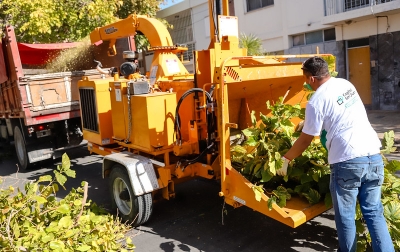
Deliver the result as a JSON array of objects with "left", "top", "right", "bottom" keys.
[{"left": 277, "top": 57, "right": 394, "bottom": 252}]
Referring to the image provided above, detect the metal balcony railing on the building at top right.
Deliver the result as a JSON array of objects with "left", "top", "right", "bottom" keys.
[{"left": 325, "top": 0, "right": 394, "bottom": 16}]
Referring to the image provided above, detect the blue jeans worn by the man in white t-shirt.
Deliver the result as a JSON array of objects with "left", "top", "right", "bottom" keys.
[{"left": 330, "top": 154, "right": 394, "bottom": 252}]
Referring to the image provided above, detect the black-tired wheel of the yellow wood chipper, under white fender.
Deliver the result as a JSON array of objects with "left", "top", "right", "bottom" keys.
[{"left": 109, "top": 164, "right": 153, "bottom": 226}]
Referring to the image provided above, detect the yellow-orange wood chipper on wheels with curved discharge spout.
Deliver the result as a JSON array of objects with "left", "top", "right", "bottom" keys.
[{"left": 78, "top": 0, "right": 334, "bottom": 227}]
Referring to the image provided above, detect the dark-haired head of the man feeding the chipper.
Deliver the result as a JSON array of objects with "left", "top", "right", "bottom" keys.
[{"left": 301, "top": 56, "right": 330, "bottom": 90}]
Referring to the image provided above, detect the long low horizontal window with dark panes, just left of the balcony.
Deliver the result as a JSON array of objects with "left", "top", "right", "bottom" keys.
[{"left": 292, "top": 28, "right": 336, "bottom": 46}]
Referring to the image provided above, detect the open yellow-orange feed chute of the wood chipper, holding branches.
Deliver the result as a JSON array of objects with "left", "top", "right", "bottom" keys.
[{"left": 218, "top": 55, "right": 332, "bottom": 228}]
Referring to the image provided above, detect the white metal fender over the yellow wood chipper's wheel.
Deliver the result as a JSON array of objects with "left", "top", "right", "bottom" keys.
[{"left": 102, "top": 151, "right": 160, "bottom": 196}]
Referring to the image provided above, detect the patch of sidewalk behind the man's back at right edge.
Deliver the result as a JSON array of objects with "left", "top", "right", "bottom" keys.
[{"left": 367, "top": 110, "right": 400, "bottom": 161}]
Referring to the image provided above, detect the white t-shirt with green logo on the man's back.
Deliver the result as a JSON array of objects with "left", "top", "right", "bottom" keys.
[{"left": 303, "top": 77, "right": 382, "bottom": 164}]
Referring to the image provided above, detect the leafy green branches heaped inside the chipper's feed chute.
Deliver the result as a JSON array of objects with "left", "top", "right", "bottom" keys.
[{"left": 231, "top": 97, "right": 332, "bottom": 208}]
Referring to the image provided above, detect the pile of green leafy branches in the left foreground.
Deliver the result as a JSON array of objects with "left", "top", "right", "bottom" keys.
[{"left": 0, "top": 154, "right": 134, "bottom": 252}]
